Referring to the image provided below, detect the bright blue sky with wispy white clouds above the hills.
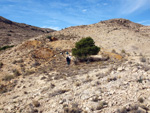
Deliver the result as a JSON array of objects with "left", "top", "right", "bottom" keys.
[{"left": 0, "top": 0, "right": 150, "bottom": 30}]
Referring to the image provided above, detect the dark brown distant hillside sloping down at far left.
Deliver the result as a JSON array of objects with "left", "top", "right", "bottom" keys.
[{"left": 0, "top": 16, "right": 54, "bottom": 47}]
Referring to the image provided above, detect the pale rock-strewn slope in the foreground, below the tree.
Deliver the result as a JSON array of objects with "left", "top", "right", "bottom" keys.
[{"left": 0, "top": 45, "right": 150, "bottom": 113}]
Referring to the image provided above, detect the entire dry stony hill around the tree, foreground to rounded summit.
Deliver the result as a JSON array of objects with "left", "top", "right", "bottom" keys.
[{"left": 0, "top": 19, "right": 150, "bottom": 113}]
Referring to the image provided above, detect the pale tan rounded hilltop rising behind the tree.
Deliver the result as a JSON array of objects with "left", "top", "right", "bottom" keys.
[{"left": 51, "top": 19, "right": 150, "bottom": 55}]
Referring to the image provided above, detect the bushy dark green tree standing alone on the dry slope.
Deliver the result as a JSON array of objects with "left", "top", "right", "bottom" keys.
[{"left": 72, "top": 37, "right": 100, "bottom": 59}]
